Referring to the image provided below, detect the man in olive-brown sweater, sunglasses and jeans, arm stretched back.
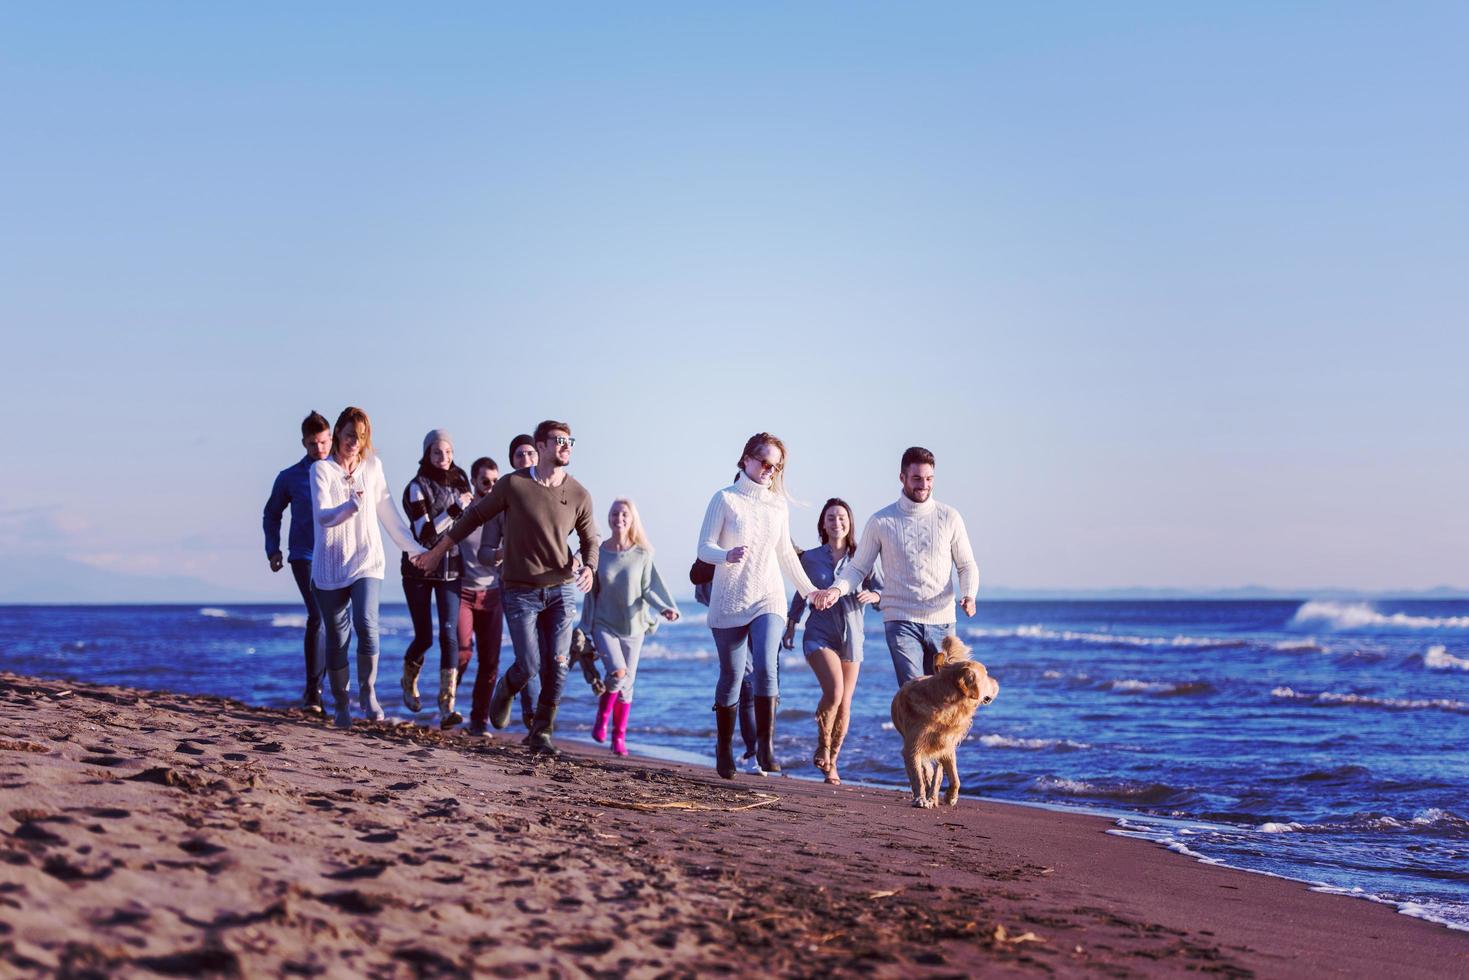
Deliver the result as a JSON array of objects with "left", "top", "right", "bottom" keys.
[{"left": 411, "top": 420, "right": 598, "bottom": 755}]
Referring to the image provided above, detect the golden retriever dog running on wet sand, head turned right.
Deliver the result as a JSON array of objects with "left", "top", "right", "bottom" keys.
[{"left": 893, "top": 636, "right": 1000, "bottom": 808}]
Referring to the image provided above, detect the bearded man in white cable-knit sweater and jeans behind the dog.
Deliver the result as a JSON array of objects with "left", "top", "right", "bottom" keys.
[{"left": 834, "top": 445, "right": 980, "bottom": 686}]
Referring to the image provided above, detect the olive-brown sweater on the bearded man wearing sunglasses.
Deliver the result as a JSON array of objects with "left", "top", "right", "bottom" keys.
[{"left": 448, "top": 470, "right": 598, "bottom": 589}]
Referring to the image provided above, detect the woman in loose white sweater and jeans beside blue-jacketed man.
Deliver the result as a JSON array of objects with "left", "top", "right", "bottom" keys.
[{"left": 311, "top": 407, "right": 425, "bottom": 729}]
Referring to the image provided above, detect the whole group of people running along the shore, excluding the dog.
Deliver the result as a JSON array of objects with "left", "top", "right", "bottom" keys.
[{"left": 264, "top": 407, "right": 978, "bottom": 783}]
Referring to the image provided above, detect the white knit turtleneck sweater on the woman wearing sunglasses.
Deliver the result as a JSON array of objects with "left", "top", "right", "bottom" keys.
[{"left": 699, "top": 473, "right": 817, "bottom": 629}]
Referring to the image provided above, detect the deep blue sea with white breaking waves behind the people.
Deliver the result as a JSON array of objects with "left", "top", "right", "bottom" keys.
[{"left": 0, "top": 599, "right": 1469, "bottom": 930}]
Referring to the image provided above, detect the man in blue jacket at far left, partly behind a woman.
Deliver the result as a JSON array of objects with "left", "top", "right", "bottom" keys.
[{"left": 264, "top": 411, "right": 332, "bottom": 714}]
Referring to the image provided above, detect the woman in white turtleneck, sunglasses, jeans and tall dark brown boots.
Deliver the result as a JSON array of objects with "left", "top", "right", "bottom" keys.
[{"left": 699, "top": 432, "right": 836, "bottom": 779}]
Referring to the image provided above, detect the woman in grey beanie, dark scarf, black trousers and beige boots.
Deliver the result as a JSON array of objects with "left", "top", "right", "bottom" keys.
[{"left": 403, "top": 429, "right": 473, "bottom": 729}]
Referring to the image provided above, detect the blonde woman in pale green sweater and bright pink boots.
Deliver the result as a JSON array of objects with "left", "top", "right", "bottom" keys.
[{"left": 582, "top": 498, "right": 679, "bottom": 755}]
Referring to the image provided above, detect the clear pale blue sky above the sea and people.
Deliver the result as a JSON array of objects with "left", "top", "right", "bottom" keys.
[{"left": 0, "top": 3, "right": 1469, "bottom": 601}]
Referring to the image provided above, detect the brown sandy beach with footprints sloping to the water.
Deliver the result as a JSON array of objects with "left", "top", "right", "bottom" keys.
[{"left": 0, "top": 674, "right": 1469, "bottom": 977}]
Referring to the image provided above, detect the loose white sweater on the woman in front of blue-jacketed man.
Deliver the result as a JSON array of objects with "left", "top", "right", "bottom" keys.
[{"left": 311, "top": 455, "right": 427, "bottom": 589}]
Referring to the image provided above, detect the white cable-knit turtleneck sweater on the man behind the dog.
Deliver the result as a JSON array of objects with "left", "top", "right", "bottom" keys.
[{"left": 836, "top": 497, "right": 980, "bottom": 626}]
